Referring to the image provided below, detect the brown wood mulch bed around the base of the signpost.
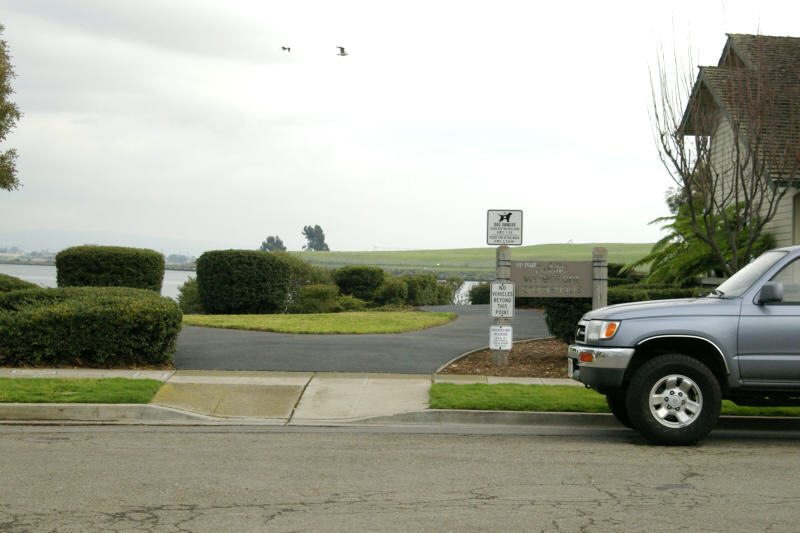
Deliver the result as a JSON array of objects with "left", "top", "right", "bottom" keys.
[{"left": 439, "top": 338, "right": 568, "bottom": 378}]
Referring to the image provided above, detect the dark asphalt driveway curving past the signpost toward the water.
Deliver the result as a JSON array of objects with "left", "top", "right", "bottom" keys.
[{"left": 175, "top": 305, "right": 548, "bottom": 374}]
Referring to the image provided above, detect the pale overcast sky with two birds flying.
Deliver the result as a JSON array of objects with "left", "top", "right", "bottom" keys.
[{"left": 0, "top": 0, "right": 800, "bottom": 255}]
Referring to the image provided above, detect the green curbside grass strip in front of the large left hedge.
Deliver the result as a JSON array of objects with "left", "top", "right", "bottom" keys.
[{"left": 0, "top": 378, "right": 161, "bottom": 403}]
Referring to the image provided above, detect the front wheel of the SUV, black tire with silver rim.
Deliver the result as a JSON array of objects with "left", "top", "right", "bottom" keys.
[{"left": 626, "top": 353, "right": 722, "bottom": 445}]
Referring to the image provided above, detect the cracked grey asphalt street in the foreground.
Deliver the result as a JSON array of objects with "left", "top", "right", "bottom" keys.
[{"left": 0, "top": 426, "right": 800, "bottom": 533}]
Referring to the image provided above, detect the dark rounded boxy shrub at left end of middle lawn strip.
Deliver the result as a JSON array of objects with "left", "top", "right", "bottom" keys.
[{"left": 197, "top": 250, "right": 290, "bottom": 314}]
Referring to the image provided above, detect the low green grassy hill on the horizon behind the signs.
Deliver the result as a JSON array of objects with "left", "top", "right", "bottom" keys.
[{"left": 292, "top": 243, "right": 653, "bottom": 279}]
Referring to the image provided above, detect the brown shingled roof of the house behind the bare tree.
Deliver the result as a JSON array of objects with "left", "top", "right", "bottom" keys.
[{"left": 680, "top": 34, "right": 800, "bottom": 170}]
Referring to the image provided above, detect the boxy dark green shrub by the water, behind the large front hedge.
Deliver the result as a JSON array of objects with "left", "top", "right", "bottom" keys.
[{"left": 56, "top": 246, "right": 164, "bottom": 294}]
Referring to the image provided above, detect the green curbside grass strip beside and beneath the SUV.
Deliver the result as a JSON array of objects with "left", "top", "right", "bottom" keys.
[{"left": 430, "top": 383, "right": 800, "bottom": 416}]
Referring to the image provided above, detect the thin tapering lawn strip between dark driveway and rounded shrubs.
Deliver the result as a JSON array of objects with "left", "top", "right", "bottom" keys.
[{"left": 183, "top": 311, "right": 456, "bottom": 334}]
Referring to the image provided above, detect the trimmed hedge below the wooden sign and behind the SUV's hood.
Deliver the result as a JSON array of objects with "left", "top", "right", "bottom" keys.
[{"left": 542, "top": 285, "right": 709, "bottom": 343}]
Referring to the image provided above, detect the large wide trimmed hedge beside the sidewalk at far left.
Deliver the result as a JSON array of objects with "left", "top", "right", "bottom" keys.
[{"left": 0, "top": 287, "right": 182, "bottom": 367}]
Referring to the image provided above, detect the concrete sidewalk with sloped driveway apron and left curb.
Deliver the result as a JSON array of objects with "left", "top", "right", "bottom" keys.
[{"left": 0, "top": 368, "right": 581, "bottom": 425}]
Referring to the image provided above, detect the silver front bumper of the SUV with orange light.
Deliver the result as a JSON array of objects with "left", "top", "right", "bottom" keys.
[{"left": 567, "top": 344, "right": 634, "bottom": 388}]
